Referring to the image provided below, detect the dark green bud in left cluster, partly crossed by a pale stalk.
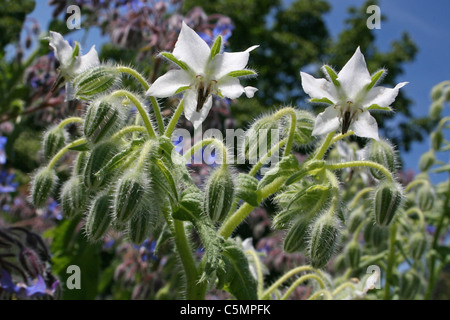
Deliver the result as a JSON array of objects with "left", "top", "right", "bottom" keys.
[{"left": 83, "top": 141, "right": 120, "bottom": 188}]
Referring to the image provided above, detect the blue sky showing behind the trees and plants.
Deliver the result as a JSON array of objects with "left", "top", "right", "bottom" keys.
[{"left": 26, "top": 0, "right": 450, "bottom": 182}]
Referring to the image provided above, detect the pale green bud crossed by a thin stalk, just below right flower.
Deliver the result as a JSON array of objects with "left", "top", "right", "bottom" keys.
[{"left": 368, "top": 140, "right": 397, "bottom": 180}]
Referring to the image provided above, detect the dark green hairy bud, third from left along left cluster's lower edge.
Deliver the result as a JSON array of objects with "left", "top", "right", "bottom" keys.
[{"left": 85, "top": 193, "right": 113, "bottom": 241}]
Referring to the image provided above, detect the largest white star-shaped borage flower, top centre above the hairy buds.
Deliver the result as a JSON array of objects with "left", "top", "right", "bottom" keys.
[{"left": 147, "top": 22, "right": 258, "bottom": 128}]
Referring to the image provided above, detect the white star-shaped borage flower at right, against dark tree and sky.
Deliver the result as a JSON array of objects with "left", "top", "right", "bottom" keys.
[{"left": 300, "top": 47, "right": 408, "bottom": 140}]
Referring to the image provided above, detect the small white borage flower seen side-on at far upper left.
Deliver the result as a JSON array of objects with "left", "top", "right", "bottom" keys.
[{"left": 48, "top": 31, "right": 100, "bottom": 101}]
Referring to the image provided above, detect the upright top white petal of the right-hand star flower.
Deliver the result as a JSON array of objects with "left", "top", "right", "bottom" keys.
[{"left": 337, "top": 47, "right": 372, "bottom": 100}]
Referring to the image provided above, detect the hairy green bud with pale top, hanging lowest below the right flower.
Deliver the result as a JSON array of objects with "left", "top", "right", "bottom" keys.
[{"left": 309, "top": 212, "right": 340, "bottom": 269}]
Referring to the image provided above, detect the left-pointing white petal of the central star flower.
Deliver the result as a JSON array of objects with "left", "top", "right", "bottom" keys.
[{"left": 146, "top": 70, "right": 192, "bottom": 98}]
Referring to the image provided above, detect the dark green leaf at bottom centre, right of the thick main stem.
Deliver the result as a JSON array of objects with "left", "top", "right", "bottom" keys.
[{"left": 217, "top": 240, "right": 258, "bottom": 300}]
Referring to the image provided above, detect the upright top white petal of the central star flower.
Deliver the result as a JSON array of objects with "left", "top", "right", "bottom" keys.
[{"left": 172, "top": 22, "right": 211, "bottom": 74}]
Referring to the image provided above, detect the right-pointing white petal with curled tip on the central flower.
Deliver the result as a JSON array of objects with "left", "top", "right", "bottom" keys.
[{"left": 209, "top": 46, "right": 258, "bottom": 80}]
